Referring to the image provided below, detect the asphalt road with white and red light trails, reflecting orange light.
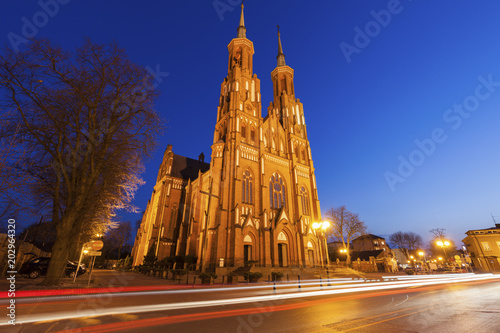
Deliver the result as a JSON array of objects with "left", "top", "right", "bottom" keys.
[{"left": 0, "top": 273, "right": 500, "bottom": 333}]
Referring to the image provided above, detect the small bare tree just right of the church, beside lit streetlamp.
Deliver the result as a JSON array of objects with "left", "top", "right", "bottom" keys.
[{"left": 326, "top": 206, "right": 366, "bottom": 265}]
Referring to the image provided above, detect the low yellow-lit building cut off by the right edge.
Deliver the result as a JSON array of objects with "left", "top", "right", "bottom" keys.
[{"left": 462, "top": 223, "right": 500, "bottom": 272}]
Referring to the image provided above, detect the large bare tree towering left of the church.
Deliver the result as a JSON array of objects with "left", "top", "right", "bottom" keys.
[{"left": 0, "top": 40, "right": 161, "bottom": 283}]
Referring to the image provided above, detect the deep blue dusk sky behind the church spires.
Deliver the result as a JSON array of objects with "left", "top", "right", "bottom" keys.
[{"left": 0, "top": 0, "right": 500, "bottom": 242}]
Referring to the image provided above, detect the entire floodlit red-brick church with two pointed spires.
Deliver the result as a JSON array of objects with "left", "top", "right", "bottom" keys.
[{"left": 132, "top": 5, "right": 328, "bottom": 273}]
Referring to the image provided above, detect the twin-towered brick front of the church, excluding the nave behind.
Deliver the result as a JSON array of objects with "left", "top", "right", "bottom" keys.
[{"left": 195, "top": 5, "right": 327, "bottom": 268}]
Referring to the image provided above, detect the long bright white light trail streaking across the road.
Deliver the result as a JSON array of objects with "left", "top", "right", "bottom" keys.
[{"left": 4, "top": 274, "right": 500, "bottom": 326}]
